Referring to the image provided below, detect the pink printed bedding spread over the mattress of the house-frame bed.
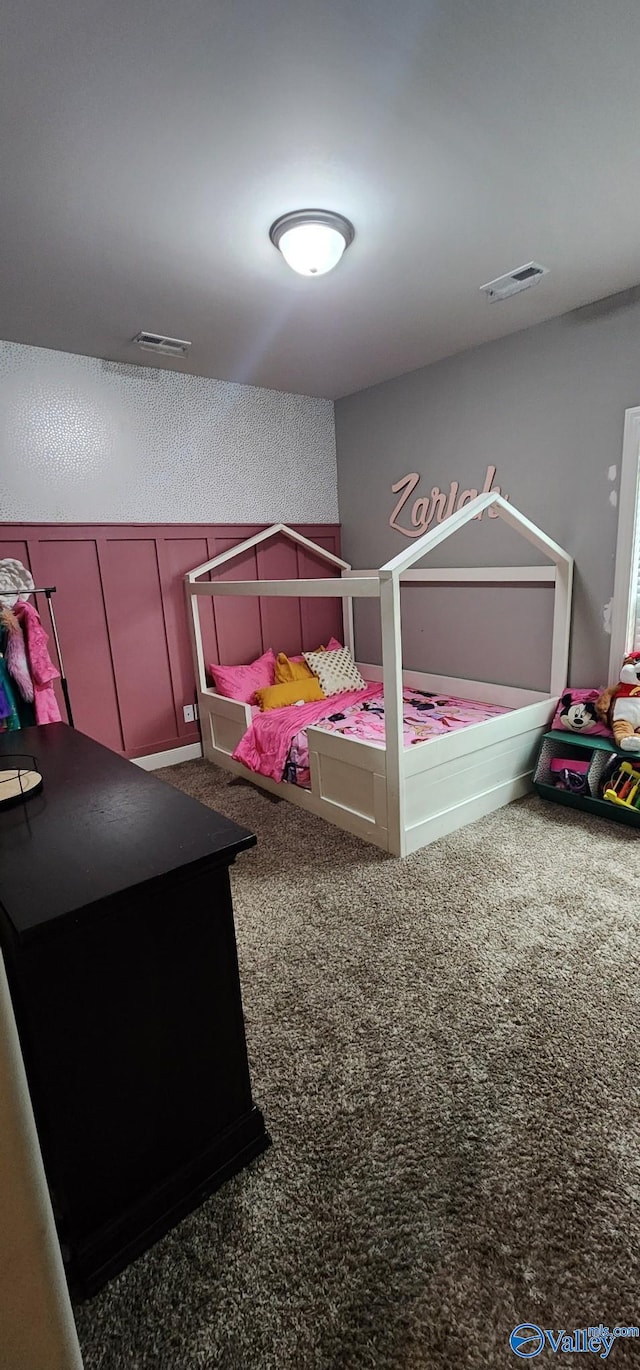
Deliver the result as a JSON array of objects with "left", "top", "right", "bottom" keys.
[{"left": 233, "top": 684, "right": 508, "bottom": 788}]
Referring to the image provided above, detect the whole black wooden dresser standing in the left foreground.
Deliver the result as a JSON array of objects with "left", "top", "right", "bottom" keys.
[{"left": 0, "top": 723, "right": 270, "bottom": 1296}]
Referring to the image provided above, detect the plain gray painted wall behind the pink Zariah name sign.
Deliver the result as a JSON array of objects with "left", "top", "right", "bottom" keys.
[{"left": 336, "top": 292, "right": 640, "bottom": 688}]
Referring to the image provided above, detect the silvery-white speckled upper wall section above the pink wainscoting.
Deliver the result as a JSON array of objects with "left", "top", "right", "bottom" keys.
[{"left": 0, "top": 343, "right": 337, "bottom": 523}]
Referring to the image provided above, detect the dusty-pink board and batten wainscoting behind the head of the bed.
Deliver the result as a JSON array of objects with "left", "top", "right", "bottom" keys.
[{"left": 0, "top": 523, "right": 341, "bottom": 758}]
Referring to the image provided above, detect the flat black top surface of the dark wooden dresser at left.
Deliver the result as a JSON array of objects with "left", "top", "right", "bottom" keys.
[{"left": 0, "top": 723, "right": 255, "bottom": 938}]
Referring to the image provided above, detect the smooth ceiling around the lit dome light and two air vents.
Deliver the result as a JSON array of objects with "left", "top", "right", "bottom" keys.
[{"left": 0, "top": 0, "right": 640, "bottom": 397}]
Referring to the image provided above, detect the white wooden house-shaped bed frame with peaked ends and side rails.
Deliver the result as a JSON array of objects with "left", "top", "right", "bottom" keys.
[{"left": 185, "top": 492, "right": 573, "bottom": 856}]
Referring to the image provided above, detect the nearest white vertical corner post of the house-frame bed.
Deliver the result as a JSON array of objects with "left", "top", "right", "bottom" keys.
[{"left": 380, "top": 570, "right": 406, "bottom": 856}]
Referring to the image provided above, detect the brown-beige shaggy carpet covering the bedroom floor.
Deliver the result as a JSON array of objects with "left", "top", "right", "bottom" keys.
[{"left": 74, "top": 762, "right": 640, "bottom": 1370}]
